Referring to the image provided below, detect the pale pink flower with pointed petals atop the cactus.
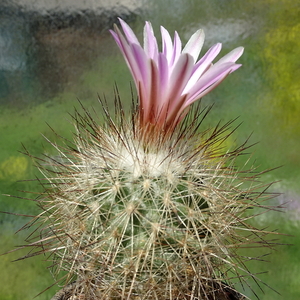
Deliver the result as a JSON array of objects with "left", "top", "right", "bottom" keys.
[{"left": 111, "top": 19, "right": 244, "bottom": 130}]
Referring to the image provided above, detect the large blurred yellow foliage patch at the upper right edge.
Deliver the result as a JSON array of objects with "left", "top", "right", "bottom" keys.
[{"left": 262, "top": 18, "right": 300, "bottom": 134}]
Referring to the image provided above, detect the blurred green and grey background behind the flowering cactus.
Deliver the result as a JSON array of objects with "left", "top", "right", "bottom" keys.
[{"left": 0, "top": 0, "right": 300, "bottom": 300}]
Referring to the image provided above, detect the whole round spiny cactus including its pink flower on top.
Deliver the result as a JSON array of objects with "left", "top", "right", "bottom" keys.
[{"left": 18, "top": 21, "right": 278, "bottom": 300}]
